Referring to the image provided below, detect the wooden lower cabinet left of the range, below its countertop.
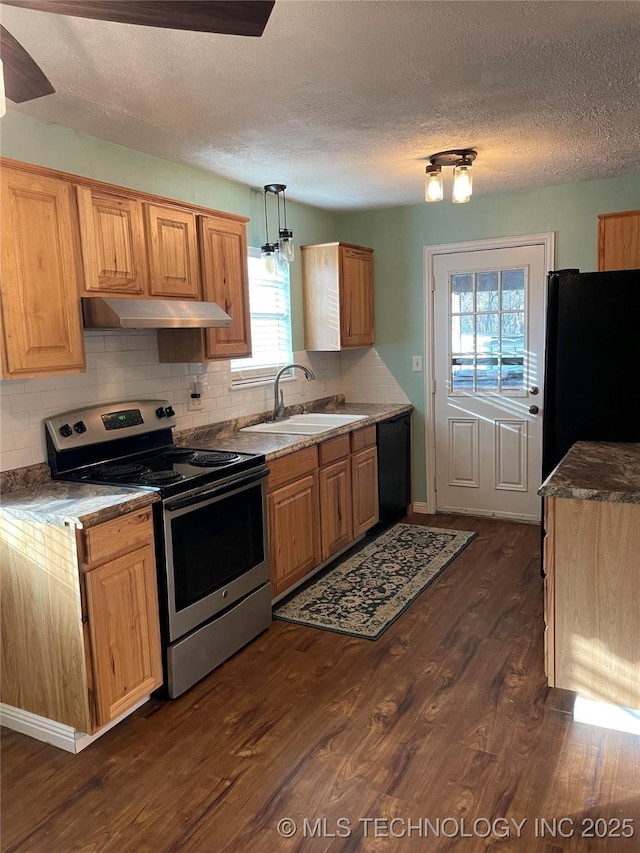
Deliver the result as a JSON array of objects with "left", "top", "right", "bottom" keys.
[{"left": 0, "top": 509, "right": 162, "bottom": 733}]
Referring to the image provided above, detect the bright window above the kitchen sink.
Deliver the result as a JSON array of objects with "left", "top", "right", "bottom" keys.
[{"left": 231, "top": 249, "right": 293, "bottom": 386}]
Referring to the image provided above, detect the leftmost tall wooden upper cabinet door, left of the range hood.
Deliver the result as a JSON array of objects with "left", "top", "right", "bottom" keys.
[{"left": 1, "top": 168, "right": 85, "bottom": 379}]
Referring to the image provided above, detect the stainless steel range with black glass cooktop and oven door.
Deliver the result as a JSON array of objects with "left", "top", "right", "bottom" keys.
[{"left": 45, "top": 400, "right": 271, "bottom": 698}]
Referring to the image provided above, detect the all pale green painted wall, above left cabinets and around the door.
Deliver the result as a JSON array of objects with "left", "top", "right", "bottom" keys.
[{"left": 0, "top": 110, "right": 640, "bottom": 500}]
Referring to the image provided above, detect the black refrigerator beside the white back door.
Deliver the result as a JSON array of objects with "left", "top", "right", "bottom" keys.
[{"left": 542, "top": 270, "right": 640, "bottom": 479}]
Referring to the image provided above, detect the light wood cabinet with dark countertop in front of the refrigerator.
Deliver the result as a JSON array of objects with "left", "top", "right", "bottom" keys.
[{"left": 540, "top": 442, "right": 640, "bottom": 709}]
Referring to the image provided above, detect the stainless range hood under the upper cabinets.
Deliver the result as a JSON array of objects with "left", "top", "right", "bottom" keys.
[{"left": 82, "top": 296, "right": 232, "bottom": 329}]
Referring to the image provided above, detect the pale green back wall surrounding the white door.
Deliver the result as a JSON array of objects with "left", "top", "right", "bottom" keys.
[{"left": 337, "top": 176, "right": 640, "bottom": 500}]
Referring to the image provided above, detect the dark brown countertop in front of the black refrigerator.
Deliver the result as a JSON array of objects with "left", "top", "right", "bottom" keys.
[{"left": 538, "top": 441, "right": 640, "bottom": 504}]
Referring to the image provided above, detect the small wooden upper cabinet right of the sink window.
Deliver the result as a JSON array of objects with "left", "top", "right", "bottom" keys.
[{"left": 301, "top": 243, "right": 374, "bottom": 352}]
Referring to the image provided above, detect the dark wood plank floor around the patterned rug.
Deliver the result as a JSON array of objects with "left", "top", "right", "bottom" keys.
[{"left": 2, "top": 515, "right": 640, "bottom": 853}]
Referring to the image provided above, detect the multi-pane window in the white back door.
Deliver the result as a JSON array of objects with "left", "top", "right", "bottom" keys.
[{"left": 449, "top": 268, "right": 527, "bottom": 395}]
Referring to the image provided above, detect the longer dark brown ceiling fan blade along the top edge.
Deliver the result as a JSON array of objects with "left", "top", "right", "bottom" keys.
[{"left": 3, "top": 0, "right": 275, "bottom": 36}]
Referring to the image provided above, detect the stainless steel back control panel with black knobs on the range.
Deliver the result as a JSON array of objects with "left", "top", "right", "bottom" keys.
[{"left": 44, "top": 400, "right": 176, "bottom": 452}]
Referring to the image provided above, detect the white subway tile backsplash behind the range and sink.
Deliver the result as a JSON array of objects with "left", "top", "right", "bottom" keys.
[{"left": 0, "top": 331, "right": 408, "bottom": 471}]
